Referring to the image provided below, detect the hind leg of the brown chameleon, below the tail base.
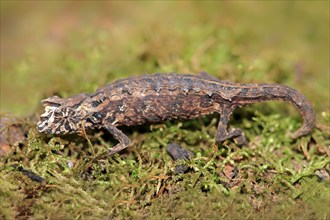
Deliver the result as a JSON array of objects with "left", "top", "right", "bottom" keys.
[{"left": 215, "top": 106, "right": 246, "bottom": 146}]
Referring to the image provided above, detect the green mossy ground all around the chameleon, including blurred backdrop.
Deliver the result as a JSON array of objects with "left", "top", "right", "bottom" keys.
[{"left": 0, "top": 1, "right": 330, "bottom": 219}]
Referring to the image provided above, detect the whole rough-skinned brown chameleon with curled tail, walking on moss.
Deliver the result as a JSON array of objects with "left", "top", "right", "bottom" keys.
[{"left": 37, "top": 73, "right": 315, "bottom": 156}]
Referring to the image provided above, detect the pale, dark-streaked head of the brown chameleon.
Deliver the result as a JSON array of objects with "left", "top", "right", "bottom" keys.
[{"left": 37, "top": 96, "right": 81, "bottom": 134}]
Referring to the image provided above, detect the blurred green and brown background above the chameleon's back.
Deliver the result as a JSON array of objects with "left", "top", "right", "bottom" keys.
[{"left": 0, "top": 0, "right": 330, "bottom": 116}]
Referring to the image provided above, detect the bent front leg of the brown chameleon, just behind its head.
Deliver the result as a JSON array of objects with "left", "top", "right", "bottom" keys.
[{"left": 105, "top": 124, "right": 131, "bottom": 156}]
